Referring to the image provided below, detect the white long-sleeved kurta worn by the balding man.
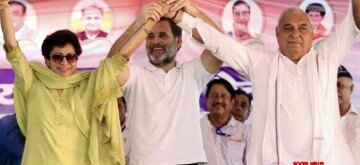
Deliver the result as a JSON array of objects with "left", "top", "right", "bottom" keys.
[{"left": 178, "top": 6, "right": 359, "bottom": 164}]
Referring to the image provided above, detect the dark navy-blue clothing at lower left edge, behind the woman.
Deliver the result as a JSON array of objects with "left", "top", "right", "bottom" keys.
[{"left": 0, "top": 114, "right": 25, "bottom": 165}]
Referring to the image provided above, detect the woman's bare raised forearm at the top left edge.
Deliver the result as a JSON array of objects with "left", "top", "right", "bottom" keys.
[{"left": 0, "top": 0, "right": 17, "bottom": 51}]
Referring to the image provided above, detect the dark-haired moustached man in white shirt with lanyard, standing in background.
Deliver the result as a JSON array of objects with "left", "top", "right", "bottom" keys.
[{"left": 201, "top": 79, "right": 250, "bottom": 165}]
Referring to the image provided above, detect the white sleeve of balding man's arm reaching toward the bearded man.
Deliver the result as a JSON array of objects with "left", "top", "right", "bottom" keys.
[{"left": 178, "top": 13, "right": 263, "bottom": 78}]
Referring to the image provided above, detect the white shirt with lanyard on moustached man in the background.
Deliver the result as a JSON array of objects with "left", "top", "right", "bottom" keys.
[{"left": 201, "top": 116, "right": 250, "bottom": 165}]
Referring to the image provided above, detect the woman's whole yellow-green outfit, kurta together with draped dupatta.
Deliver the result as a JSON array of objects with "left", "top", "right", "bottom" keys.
[{"left": 7, "top": 48, "right": 126, "bottom": 165}]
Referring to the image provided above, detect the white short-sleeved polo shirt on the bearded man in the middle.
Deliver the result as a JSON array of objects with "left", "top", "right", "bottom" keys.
[{"left": 122, "top": 58, "right": 213, "bottom": 165}]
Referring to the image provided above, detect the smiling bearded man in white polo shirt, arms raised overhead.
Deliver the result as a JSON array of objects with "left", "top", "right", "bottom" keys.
[{"left": 105, "top": 0, "right": 222, "bottom": 165}]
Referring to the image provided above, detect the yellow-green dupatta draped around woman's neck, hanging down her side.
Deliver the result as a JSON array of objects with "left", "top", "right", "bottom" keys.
[{"left": 14, "top": 55, "right": 127, "bottom": 165}]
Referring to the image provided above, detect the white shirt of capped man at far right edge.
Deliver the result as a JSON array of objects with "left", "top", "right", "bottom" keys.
[{"left": 341, "top": 106, "right": 360, "bottom": 164}]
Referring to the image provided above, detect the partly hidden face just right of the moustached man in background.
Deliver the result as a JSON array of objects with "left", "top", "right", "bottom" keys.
[{"left": 231, "top": 89, "right": 251, "bottom": 123}]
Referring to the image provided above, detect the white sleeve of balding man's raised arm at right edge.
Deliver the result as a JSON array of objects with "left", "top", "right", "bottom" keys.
[{"left": 316, "top": 3, "right": 360, "bottom": 65}]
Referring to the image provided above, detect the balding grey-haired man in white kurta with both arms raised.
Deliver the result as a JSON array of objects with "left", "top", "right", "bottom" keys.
[{"left": 176, "top": 2, "right": 360, "bottom": 165}]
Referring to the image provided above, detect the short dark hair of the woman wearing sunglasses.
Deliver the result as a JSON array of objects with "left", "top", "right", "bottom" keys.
[{"left": 41, "top": 29, "right": 82, "bottom": 59}]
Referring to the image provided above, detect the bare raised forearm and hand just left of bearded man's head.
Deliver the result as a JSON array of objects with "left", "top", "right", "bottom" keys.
[{"left": 107, "top": 2, "right": 163, "bottom": 60}]
